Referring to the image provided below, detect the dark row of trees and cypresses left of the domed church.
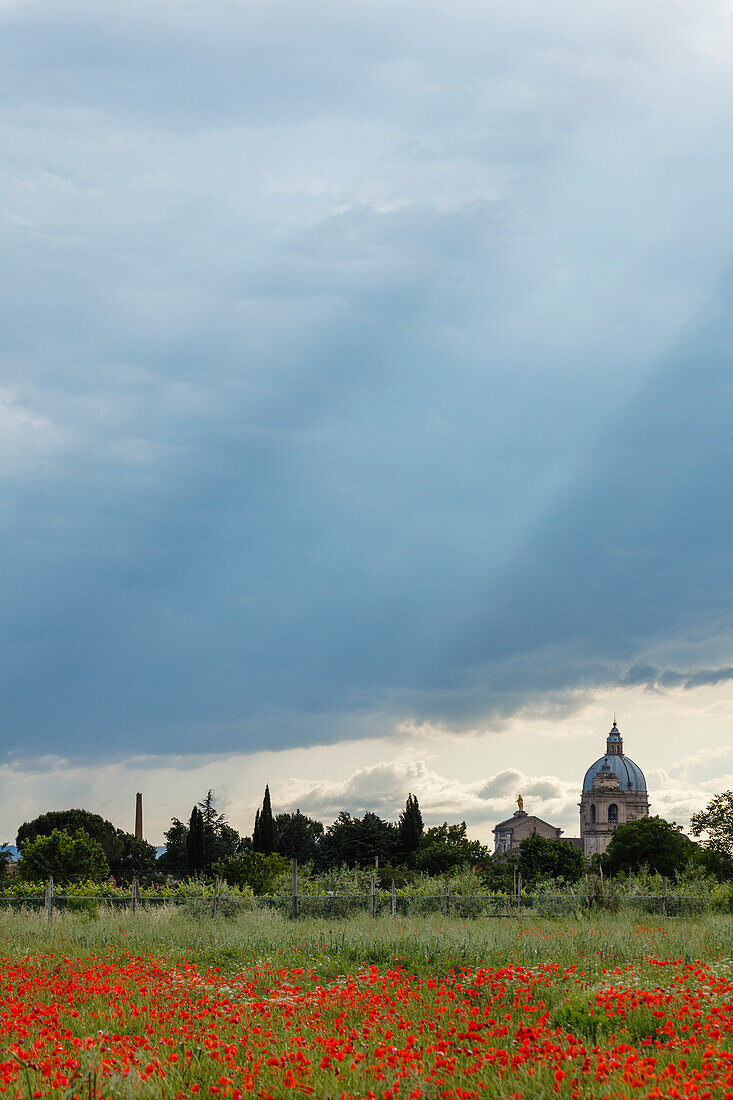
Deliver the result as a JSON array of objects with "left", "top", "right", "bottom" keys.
[{"left": 0, "top": 785, "right": 490, "bottom": 887}]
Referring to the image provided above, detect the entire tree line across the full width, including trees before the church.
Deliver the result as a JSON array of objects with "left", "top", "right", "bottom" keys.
[{"left": 0, "top": 787, "right": 733, "bottom": 893}]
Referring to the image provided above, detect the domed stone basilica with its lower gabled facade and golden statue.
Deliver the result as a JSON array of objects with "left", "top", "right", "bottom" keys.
[{"left": 493, "top": 718, "right": 649, "bottom": 857}]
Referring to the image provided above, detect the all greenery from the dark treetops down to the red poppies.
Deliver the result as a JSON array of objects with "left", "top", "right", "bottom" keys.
[{"left": 0, "top": 789, "right": 733, "bottom": 1100}]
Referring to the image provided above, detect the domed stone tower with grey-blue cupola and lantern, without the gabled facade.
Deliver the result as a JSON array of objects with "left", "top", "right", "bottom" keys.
[{"left": 579, "top": 718, "right": 649, "bottom": 856}]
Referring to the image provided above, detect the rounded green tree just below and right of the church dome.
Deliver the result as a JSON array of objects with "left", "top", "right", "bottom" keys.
[{"left": 602, "top": 817, "right": 697, "bottom": 879}]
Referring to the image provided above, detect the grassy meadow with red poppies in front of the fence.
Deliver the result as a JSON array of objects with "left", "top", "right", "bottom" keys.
[{"left": 0, "top": 912, "right": 733, "bottom": 1100}]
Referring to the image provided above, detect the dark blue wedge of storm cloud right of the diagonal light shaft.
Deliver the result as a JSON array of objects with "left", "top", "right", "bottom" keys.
[{"left": 416, "top": 305, "right": 733, "bottom": 721}]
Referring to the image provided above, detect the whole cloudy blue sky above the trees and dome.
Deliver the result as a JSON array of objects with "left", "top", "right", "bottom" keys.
[{"left": 0, "top": 0, "right": 733, "bottom": 844}]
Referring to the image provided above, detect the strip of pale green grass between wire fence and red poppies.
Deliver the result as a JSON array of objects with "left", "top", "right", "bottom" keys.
[{"left": 0, "top": 908, "right": 733, "bottom": 977}]
